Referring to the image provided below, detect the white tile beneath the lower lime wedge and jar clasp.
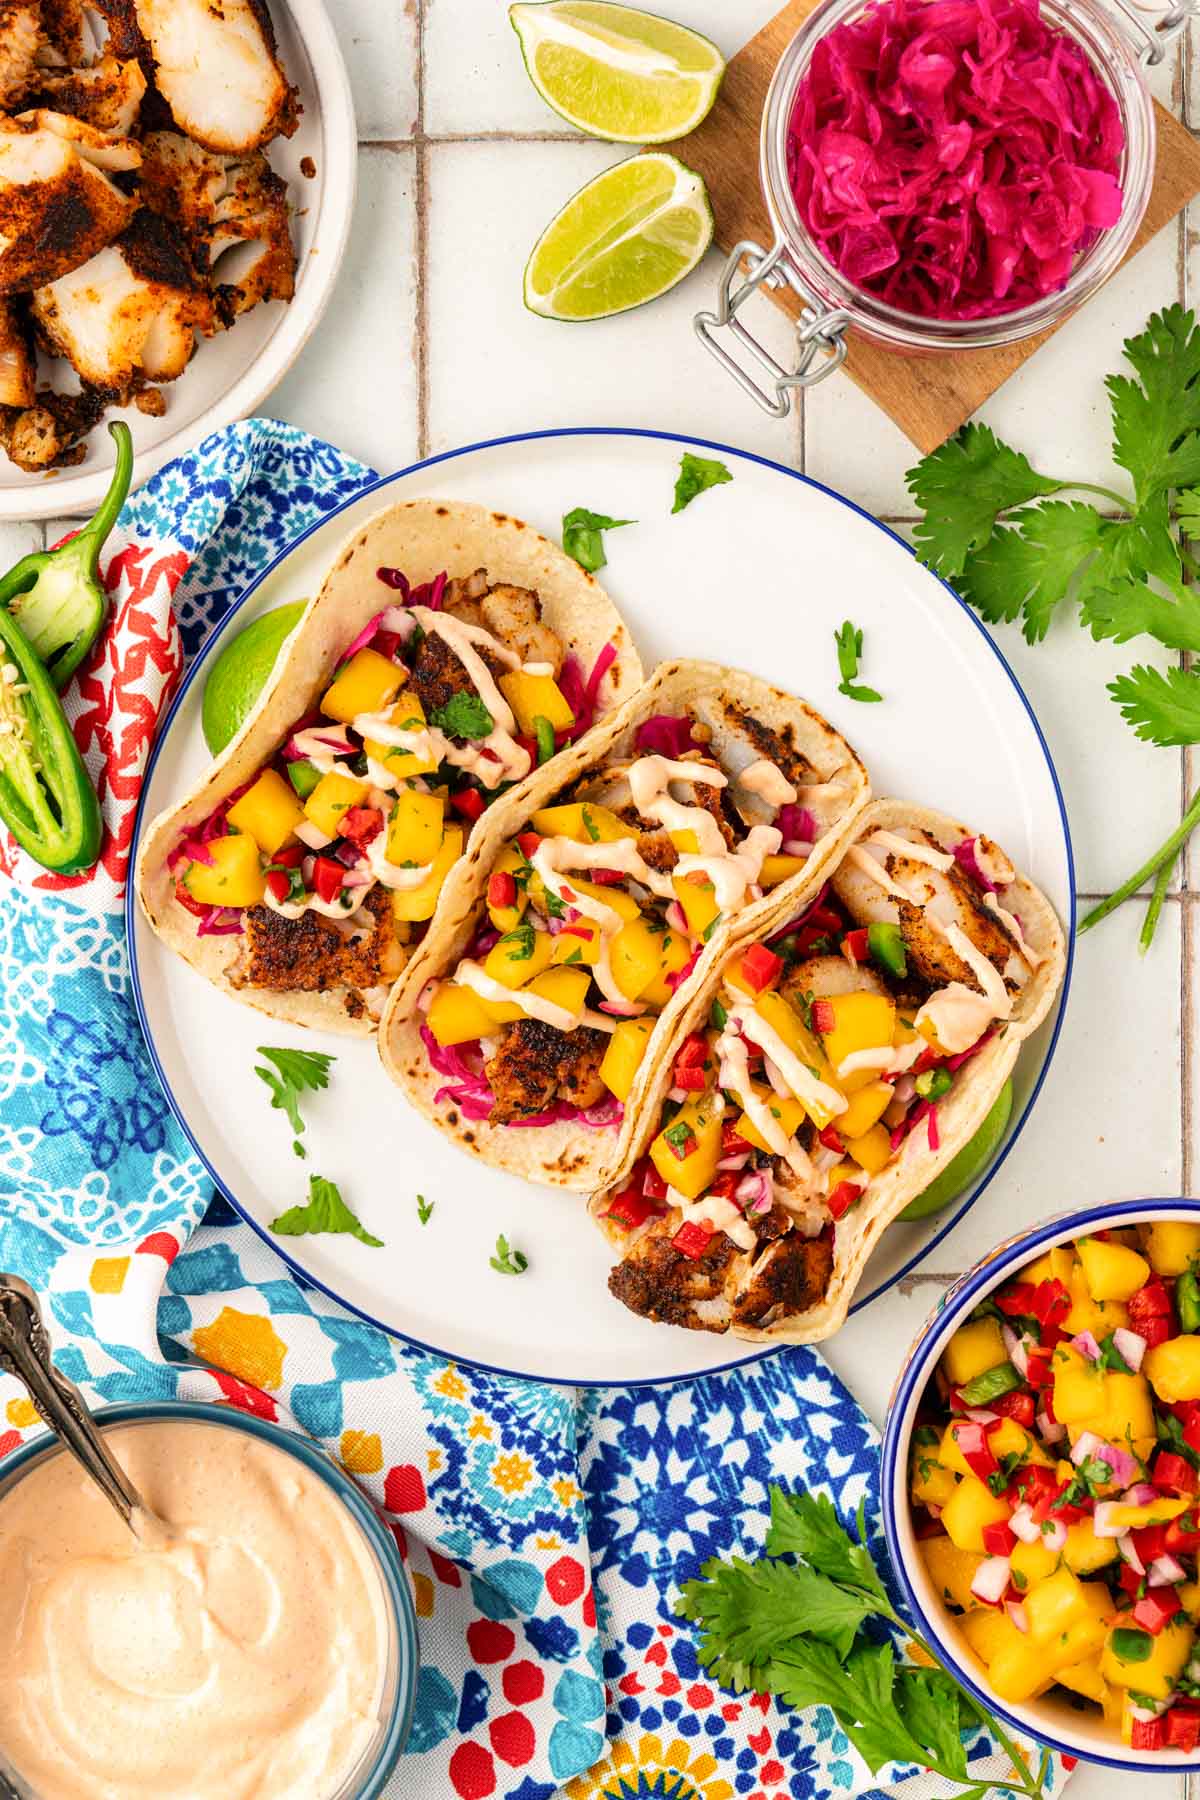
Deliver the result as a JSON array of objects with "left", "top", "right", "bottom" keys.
[{"left": 428, "top": 142, "right": 799, "bottom": 463}]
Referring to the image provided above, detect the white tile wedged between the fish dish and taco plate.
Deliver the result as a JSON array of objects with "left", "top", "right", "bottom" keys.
[{"left": 263, "top": 148, "right": 417, "bottom": 473}]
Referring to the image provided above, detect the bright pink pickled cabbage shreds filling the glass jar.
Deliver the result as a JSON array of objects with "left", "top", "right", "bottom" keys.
[{"left": 788, "top": 0, "right": 1124, "bottom": 319}]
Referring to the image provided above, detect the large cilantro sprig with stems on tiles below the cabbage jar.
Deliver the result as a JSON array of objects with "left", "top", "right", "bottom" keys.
[{"left": 907, "top": 306, "right": 1200, "bottom": 950}]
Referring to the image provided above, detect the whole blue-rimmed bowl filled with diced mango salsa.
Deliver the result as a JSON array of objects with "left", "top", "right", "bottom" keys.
[{"left": 882, "top": 1199, "right": 1200, "bottom": 1773}]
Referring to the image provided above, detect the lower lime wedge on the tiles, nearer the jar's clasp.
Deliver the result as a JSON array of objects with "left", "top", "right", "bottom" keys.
[{"left": 525, "top": 149, "right": 712, "bottom": 319}]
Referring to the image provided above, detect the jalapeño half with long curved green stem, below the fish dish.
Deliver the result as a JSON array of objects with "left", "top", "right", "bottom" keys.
[{"left": 0, "top": 419, "right": 133, "bottom": 688}]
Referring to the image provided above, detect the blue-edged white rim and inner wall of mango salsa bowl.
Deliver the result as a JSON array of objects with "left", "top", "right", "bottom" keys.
[{"left": 880, "top": 1199, "right": 1200, "bottom": 1775}]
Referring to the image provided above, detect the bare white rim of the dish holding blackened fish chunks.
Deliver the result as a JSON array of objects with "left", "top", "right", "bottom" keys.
[{"left": 0, "top": 0, "right": 356, "bottom": 520}]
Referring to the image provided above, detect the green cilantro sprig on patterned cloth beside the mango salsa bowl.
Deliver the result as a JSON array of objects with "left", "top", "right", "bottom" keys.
[{"left": 676, "top": 1487, "right": 1051, "bottom": 1800}]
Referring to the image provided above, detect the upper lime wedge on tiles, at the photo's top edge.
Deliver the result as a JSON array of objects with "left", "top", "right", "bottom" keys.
[{"left": 509, "top": 0, "right": 725, "bottom": 144}]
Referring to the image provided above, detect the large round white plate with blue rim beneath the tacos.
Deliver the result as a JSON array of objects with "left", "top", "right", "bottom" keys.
[{"left": 128, "top": 428, "right": 1074, "bottom": 1386}]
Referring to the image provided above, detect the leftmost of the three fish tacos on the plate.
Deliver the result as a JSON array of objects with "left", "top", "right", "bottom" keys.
[{"left": 137, "top": 499, "right": 642, "bottom": 1033}]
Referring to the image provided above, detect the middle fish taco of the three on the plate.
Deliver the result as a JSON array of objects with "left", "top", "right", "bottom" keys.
[{"left": 380, "top": 662, "right": 867, "bottom": 1192}]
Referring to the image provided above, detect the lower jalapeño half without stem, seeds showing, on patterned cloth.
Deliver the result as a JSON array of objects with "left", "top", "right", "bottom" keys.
[{"left": 0, "top": 607, "right": 101, "bottom": 875}]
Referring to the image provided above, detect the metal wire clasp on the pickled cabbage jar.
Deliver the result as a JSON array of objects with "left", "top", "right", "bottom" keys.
[{"left": 693, "top": 238, "right": 849, "bottom": 419}]
